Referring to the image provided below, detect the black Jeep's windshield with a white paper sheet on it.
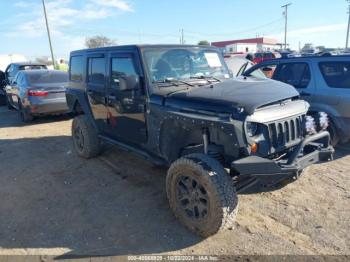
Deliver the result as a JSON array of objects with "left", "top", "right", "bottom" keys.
[{"left": 144, "top": 48, "right": 230, "bottom": 86}]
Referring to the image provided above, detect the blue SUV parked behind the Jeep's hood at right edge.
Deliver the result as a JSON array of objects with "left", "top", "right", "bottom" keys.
[{"left": 244, "top": 55, "right": 350, "bottom": 145}]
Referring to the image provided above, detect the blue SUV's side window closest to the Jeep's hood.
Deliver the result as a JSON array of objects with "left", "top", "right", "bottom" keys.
[{"left": 274, "top": 63, "right": 311, "bottom": 88}]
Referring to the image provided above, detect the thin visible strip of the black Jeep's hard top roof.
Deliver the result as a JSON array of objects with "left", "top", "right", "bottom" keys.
[{"left": 71, "top": 44, "right": 218, "bottom": 54}]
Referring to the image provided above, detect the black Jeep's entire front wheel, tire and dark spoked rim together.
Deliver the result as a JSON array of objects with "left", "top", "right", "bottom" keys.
[{"left": 166, "top": 154, "right": 238, "bottom": 237}]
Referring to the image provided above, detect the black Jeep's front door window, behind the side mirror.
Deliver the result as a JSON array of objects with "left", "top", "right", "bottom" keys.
[{"left": 111, "top": 57, "right": 137, "bottom": 89}]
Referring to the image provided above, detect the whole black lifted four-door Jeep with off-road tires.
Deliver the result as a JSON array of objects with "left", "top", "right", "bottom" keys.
[{"left": 66, "top": 45, "right": 333, "bottom": 236}]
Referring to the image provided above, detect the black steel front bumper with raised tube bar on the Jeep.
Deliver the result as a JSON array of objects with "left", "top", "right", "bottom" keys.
[{"left": 231, "top": 131, "right": 334, "bottom": 176}]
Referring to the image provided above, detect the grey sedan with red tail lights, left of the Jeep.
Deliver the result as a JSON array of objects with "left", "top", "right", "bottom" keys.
[{"left": 6, "top": 70, "right": 68, "bottom": 122}]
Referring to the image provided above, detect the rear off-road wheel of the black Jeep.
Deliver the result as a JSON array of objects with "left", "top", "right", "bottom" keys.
[{"left": 72, "top": 115, "right": 101, "bottom": 159}]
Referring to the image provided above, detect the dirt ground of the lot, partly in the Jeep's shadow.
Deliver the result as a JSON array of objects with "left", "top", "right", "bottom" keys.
[{"left": 0, "top": 107, "right": 350, "bottom": 256}]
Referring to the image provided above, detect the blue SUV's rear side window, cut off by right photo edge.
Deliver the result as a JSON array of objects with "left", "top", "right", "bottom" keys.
[{"left": 319, "top": 61, "right": 350, "bottom": 88}]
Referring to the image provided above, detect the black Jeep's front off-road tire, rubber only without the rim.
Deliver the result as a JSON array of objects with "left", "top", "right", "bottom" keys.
[{"left": 166, "top": 154, "right": 238, "bottom": 237}]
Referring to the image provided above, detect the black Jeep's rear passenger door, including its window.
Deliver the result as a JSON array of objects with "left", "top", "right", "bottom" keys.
[{"left": 87, "top": 53, "right": 108, "bottom": 133}]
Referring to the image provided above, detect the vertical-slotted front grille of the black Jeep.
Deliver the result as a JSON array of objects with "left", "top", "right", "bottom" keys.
[{"left": 268, "top": 116, "right": 303, "bottom": 153}]
